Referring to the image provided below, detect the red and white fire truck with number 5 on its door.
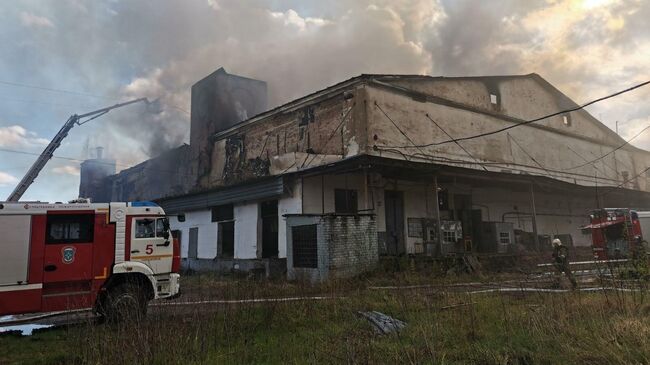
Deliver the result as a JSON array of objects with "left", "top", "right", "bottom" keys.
[{"left": 0, "top": 202, "right": 180, "bottom": 318}]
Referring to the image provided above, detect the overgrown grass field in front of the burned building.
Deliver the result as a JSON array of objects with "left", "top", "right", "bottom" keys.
[{"left": 0, "top": 273, "right": 650, "bottom": 364}]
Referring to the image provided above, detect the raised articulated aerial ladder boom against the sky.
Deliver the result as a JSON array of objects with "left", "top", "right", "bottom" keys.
[{"left": 7, "top": 98, "right": 149, "bottom": 202}]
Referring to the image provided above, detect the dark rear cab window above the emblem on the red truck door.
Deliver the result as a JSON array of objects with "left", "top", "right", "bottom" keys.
[{"left": 45, "top": 214, "right": 95, "bottom": 244}]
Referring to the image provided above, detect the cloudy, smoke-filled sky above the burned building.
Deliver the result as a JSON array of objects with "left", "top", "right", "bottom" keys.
[{"left": 0, "top": 0, "right": 650, "bottom": 201}]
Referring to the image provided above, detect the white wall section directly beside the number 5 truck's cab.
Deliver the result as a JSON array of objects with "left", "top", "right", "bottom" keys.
[{"left": 169, "top": 210, "right": 217, "bottom": 259}]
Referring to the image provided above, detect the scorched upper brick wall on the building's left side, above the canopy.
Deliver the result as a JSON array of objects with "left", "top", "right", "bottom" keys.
[{"left": 206, "top": 93, "right": 365, "bottom": 187}]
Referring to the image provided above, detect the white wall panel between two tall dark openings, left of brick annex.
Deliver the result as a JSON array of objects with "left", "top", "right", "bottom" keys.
[{"left": 234, "top": 202, "right": 260, "bottom": 259}]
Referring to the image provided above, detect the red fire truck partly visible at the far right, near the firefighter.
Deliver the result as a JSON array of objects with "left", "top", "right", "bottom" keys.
[{"left": 583, "top": 208, "right": 650, "bottom": 260}]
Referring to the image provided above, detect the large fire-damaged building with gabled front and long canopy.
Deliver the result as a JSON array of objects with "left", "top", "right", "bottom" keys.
[{"left": 79, "top": 69, "right": 650, "bottom": 279}]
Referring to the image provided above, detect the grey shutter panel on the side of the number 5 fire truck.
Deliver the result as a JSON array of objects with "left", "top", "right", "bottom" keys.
[{"left": 0, "top": 215, "right": 31, "bottom": 285}]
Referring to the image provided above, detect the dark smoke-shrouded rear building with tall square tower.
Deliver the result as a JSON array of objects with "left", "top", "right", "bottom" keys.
[{"left": 79, "top": 68, "right": 267, "bottom": 202}]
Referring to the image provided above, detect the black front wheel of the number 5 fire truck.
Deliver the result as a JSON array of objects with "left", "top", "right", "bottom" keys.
[{"left": 103, "top": 283, "right": 147, "bottom": 323}]
